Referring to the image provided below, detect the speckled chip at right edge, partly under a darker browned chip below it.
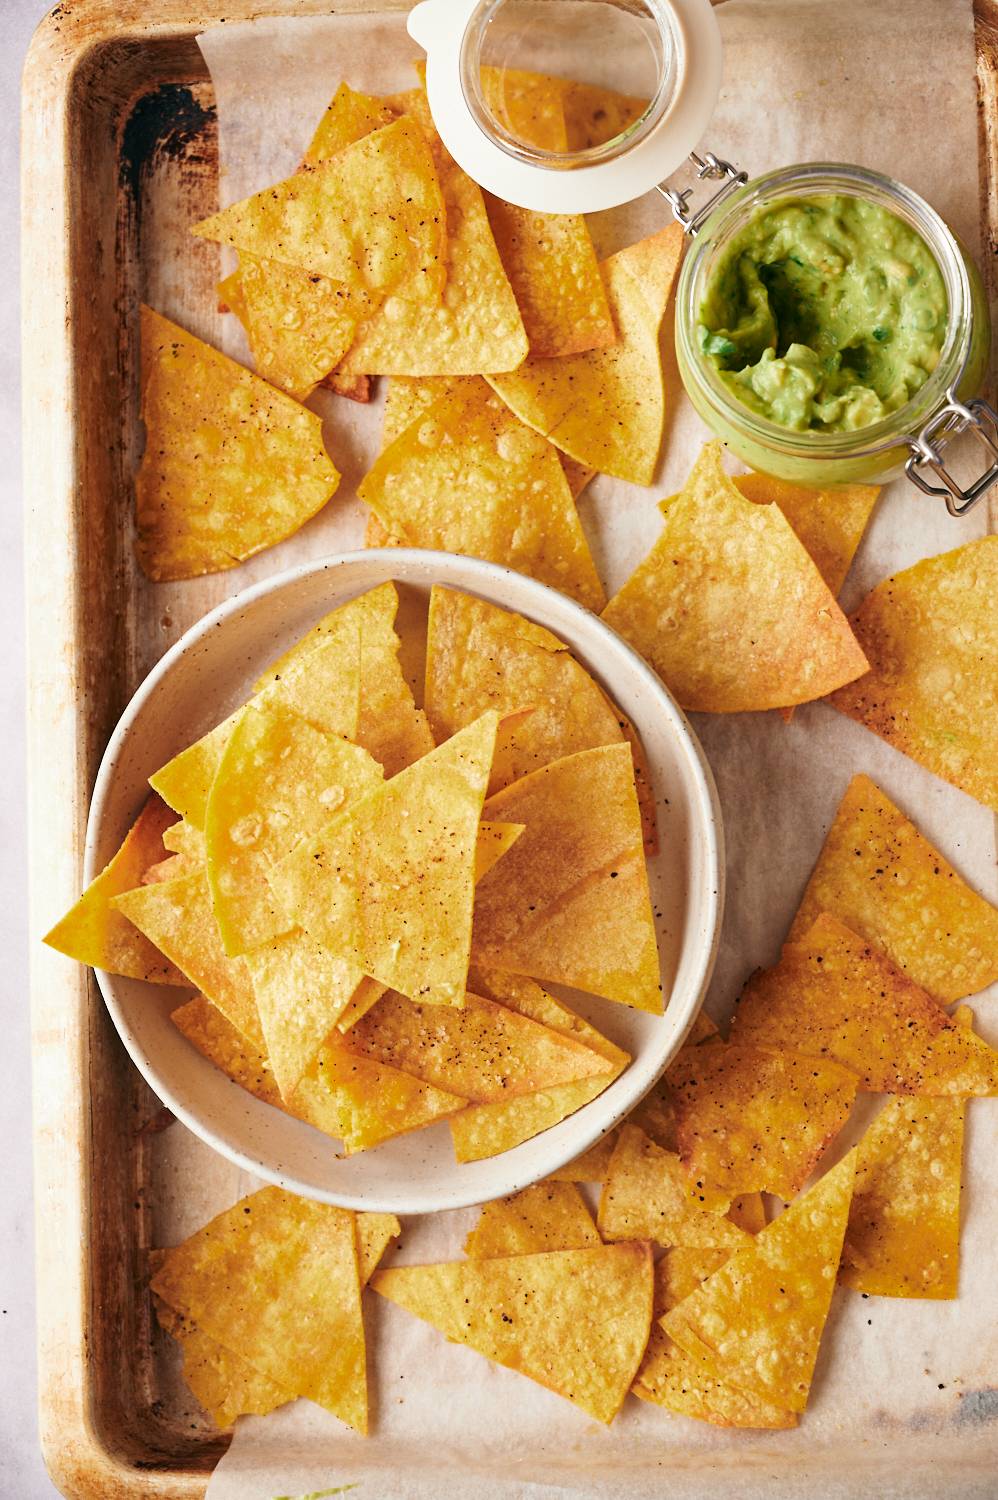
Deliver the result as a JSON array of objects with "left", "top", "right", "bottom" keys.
[{"left": 786, "top": 776, "right": 998, "bottom": 1005}]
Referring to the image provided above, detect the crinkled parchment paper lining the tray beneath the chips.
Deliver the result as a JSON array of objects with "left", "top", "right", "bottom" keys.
[{"left": 191, "top": 0, "right": 998, "bottom": 1500}]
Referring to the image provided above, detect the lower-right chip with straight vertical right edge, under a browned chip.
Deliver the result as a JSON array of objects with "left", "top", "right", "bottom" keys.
[{"left": 839, "top": 1007, "right": 971, "bottom": 1298}]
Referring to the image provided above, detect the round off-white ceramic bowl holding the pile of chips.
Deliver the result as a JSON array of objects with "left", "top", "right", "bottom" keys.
[{"left": 84, "top": 549, "right": 723, "bottom": 1214}]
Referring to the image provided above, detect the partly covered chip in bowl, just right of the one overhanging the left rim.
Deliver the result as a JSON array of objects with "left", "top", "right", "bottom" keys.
[{"left": 113, "top": 870, "right": 263, "bottom": 1043}]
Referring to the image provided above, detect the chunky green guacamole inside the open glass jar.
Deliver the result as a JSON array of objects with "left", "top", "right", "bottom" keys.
[{"left": 698, "top": 195, "right": 947, "bottom": 432}]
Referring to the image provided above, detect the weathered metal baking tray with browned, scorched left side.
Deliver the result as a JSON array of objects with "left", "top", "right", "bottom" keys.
[{"left": 24, "top": 0, "right": 998, "bottom": 1500}]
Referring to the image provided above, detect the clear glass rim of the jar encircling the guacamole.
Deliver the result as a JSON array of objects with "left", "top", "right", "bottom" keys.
[{"left": 675, "top": 162, "right": 972, "bottom": 458}]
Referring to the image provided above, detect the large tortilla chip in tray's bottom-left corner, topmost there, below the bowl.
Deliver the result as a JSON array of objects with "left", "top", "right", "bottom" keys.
[{"left": 152, "top": 1188, "right": 368, "bottom": 1433}]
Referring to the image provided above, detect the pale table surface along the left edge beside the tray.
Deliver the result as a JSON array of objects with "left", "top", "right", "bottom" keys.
[{"left": 0, "top": 0, "right": 70, "bottom": 1500}]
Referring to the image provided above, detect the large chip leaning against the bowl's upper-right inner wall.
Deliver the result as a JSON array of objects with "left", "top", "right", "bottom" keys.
[{"left": 425, "top": 584, "right": 656, "bottom": 848}]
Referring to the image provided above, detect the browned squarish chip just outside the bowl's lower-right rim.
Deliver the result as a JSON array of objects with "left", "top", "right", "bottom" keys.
[{"left": 669, "top": 1040, "right": 858, "bottom": 1202}]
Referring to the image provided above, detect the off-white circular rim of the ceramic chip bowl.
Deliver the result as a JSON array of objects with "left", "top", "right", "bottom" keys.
[{"left": 83, "top": 548, "right": 725, "bottom": 1214}]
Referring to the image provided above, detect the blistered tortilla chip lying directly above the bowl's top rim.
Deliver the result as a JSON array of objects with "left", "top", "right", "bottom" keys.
[{"left": 357, "top": 380, "right": 605, "bottom": 608}]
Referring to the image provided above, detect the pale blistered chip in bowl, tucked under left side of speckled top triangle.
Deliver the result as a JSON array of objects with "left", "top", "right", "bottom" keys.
[{"left": 204, "top": 699, "right": 384, "bottom": 954}]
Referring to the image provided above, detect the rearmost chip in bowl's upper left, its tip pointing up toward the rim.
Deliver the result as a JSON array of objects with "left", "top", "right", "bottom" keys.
[{"left": 257, "top": 582, "right": 434, "bottom": 777}]
